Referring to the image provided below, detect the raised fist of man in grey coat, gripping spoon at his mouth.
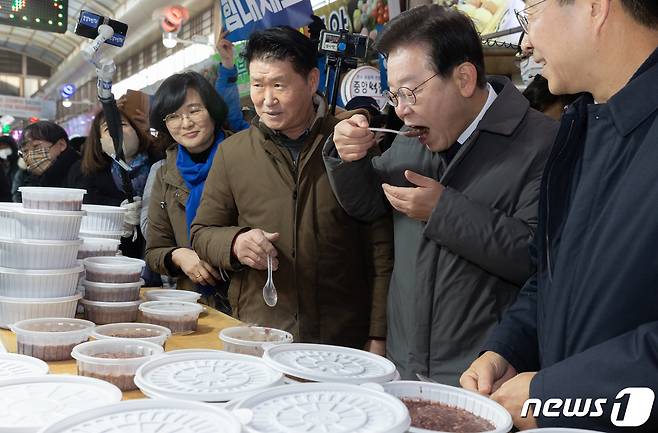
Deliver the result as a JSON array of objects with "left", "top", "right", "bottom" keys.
[{"left": 334, "top": 114, "right": 376, "bottom": 162}]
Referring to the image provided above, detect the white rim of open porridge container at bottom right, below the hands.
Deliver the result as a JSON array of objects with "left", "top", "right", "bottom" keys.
[{"left": 381, "top": 381, "right": 513, "bottom": 433}]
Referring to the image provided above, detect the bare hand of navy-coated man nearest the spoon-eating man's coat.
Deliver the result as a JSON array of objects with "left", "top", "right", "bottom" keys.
[{"left": 459, "top": 352, "right": 517, "bottom": 396}]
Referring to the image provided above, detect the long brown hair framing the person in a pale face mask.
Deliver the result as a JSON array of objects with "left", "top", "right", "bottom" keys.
[{"left": 80, "top": 109, "right": 157, "bottom": 176}]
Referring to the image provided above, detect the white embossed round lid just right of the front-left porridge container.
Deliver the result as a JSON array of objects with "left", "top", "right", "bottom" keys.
[{"left": 135, "top": 351, "right": 283, "bottom": 402}]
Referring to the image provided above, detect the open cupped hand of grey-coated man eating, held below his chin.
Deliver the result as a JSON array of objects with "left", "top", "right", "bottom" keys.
[{"left": 382, "top": 170, "right": 445, "bottom": 221}]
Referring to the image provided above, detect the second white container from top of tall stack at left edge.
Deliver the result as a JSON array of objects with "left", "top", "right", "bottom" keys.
[{"left": 0, "top": 203, "right": 84, "bottom": 240}]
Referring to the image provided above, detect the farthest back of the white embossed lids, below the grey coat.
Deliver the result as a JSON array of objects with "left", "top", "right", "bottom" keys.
[{"left": 263, "top": 343, "right": 395, "bottom": 384}]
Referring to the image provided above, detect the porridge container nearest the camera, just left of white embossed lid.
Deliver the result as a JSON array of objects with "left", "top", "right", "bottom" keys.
[{"left": 71, "top": 338, "right": 164, "bottom": 391}]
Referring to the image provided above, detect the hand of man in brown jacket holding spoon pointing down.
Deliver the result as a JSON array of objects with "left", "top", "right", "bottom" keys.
[{"left": 233, "top": 229, "right": 280, "bottom": 271}]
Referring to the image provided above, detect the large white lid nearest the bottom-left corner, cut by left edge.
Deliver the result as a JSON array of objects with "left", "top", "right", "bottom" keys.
[{"left": 0, "top": 375, "right": 122, "bottom": 433}]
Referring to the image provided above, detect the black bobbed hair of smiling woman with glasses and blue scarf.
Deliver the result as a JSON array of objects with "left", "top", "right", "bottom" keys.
[{"left": 149, "top": 71, "right": 228, "bottom": 149}]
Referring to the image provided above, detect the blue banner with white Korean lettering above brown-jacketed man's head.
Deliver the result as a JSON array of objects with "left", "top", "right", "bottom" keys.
[{"left": 220, "top": 0, "right": 313, "bottom": 42}]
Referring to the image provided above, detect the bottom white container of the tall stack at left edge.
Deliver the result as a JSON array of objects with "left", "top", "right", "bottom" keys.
[{"left": 0, "top": 293, "right": 82, "bottom": 329}]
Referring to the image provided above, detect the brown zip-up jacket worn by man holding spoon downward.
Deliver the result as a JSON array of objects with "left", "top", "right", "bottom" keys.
[{"left": 191, "top": 100, "right": 392, "bottom": 347}]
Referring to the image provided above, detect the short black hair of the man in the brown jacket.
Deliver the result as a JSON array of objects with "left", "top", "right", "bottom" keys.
[{"left": 242, "top": 26, "right": 317, "bottom": 77}]
